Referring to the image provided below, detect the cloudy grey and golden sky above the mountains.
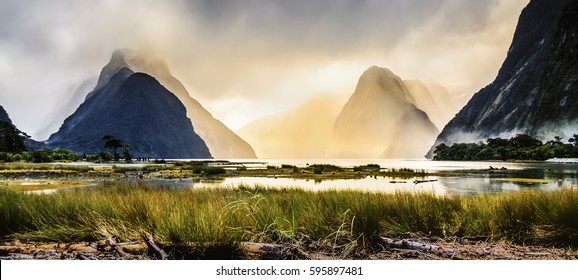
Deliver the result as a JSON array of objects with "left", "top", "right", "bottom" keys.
[{"left": 0, "top": 0, "right": 528, "bottom": 140}]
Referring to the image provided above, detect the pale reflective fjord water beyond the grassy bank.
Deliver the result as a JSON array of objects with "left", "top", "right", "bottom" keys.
[{"left": 170, "top": 159, "right": 578, "bottom": 195}]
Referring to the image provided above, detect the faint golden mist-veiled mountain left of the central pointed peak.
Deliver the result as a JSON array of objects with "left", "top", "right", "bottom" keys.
[{"left": 237, "top": 95, "right": 345, "bottom": 159}]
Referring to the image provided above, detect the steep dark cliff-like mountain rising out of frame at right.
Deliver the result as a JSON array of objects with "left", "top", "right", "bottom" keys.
[{"left": 432, "top": 0, "right": 578, "bottom": 149}]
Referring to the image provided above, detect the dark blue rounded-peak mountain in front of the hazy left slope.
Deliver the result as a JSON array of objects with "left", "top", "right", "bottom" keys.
[{"left": 46, "top": 68, "right": 211, "bottom": 158}]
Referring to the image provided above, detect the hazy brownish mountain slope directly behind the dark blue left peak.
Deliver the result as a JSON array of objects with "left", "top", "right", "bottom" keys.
[{"left": 96, "top": 49, "right": 256, "bottom": 159}]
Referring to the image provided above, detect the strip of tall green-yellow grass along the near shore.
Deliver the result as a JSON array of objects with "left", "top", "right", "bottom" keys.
[{"left": 0, "top": 182, "right": 578, "bottom": 254}]
